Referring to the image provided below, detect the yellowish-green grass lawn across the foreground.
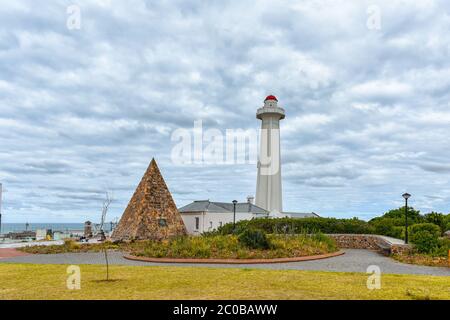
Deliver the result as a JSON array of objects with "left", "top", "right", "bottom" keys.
[{"left": 0, "top": 264, "right": 450, "bottom": 300}]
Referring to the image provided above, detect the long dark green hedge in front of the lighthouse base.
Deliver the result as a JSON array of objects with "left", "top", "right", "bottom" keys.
[{"left": 217, "top": 218, "right": 375, "bottom": 234}]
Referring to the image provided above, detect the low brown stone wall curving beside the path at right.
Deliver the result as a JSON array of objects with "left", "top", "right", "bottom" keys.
[{"left": 328, "top": 234, "right": 411, "bottom": 254}]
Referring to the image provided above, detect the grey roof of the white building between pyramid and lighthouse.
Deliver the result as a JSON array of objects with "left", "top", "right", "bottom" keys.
[{"left": 178, "top": 200, "right": 269, "bottom": 214}]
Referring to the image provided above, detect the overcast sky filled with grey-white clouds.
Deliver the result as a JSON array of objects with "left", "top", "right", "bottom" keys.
[{"left": 0, "top": 0, "right": 450, "bottom": 222}]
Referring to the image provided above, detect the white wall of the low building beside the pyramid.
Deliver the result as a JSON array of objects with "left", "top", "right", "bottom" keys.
[{"left": 181, "top": 212, "right": 253, "bottom": 235}]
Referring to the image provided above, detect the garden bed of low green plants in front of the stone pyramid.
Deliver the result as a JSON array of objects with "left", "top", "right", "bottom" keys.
[{"left": 20, "top": 234, "right": 338, "bottom": 259}]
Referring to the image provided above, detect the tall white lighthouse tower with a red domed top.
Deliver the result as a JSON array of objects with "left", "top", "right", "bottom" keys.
[{"left": 255, "top": 95, "right": 285, "bottom": 216}]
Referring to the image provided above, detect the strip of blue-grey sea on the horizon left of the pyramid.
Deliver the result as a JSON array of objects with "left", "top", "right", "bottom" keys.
[{"left": 0, "top": 222, "right": 111, "bottom": 234}]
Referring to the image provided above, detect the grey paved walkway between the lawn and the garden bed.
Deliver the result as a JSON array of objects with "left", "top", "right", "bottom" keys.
[{"left": 0, "top": 249, "right": 450, "bottom": 276}]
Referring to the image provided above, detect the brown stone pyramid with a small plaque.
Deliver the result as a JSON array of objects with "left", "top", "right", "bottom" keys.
[{"left": 111, "top": 159, "right": 186, "bottom": 240}]
